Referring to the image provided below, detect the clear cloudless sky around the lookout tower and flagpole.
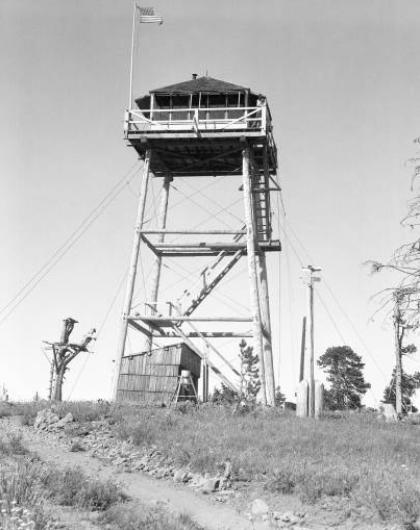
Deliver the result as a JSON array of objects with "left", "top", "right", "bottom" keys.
[{"left": 0, "top": 0, "right": 420, "bottom": 403}]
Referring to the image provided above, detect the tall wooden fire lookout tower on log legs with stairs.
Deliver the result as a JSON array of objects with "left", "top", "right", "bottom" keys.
[{"left": 115, "top": 75, "right": 281, "bottom": 405}]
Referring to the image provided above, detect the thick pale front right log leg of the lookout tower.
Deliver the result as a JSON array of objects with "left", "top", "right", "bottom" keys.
[{"left": 242, "top": 147, "right": 267, "bottom": 405}]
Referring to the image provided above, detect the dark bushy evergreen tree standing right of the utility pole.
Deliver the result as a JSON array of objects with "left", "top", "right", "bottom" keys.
[{"left": 318, "top": 346, "right": 370, "bottom": 410}]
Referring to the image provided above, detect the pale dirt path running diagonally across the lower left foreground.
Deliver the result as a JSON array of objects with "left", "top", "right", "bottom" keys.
[{"left": 2, "top": 422, "right": 268, "bottom": 530}]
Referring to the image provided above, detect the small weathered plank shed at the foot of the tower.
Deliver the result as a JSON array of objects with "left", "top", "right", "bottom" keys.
[{"left": 117, "top": 342, "right": 201, "bottom": 404}]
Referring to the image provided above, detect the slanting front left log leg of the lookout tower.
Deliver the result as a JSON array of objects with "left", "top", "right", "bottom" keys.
[{"left": 114, "top": 149, "right": 152, "bottom": 399}]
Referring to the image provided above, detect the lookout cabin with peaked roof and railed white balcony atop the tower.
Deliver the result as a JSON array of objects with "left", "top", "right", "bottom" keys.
[{"left": 125, "top": 75, "right": 277, "bottom": 180}]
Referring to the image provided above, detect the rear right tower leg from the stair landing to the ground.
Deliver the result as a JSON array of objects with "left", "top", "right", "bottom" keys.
[{"left": 257, "top": 252, "right": 275, "bottom": 407}]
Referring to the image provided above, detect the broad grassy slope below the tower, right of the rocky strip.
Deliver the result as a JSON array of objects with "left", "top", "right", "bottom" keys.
[{"left": 113, "top": 406, "right": 420, "bottom": 524}]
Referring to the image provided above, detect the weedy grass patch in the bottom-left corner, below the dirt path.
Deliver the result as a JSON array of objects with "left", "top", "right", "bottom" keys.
[{"left": 0, "top": 426, "right": 200, "bottom": 530}]
